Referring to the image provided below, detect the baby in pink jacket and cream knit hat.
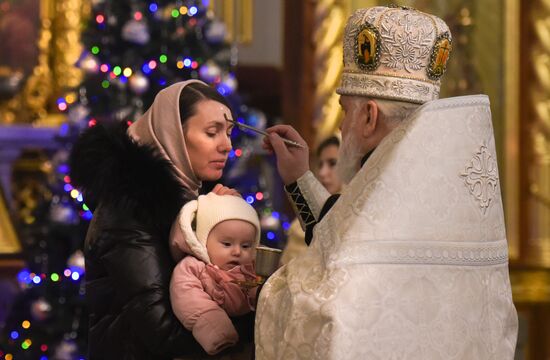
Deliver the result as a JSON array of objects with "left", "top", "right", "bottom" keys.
[{"left": 170, "top": 193, "right": 260, "bottom": 355}]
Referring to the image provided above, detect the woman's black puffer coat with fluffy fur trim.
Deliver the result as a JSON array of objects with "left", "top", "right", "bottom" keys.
[{"left": 70, "top": 122, "right": 254, "bottom": 360}]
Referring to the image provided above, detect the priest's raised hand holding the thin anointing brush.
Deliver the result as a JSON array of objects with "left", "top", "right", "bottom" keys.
[{"left": 263, "top": 125, "right": 309, "bottom": 185}]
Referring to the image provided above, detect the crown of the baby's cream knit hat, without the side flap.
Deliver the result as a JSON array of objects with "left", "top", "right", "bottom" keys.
[{"left": 196, "top": 193, "right": 261, "bottom": 247}]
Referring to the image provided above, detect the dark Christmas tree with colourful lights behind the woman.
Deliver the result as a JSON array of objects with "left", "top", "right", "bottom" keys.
[{"left": 0, "top": 0, "right": 288, "bottom": 360}]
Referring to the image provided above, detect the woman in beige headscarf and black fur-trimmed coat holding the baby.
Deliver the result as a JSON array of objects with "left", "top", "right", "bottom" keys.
[{"left": 70, "top": 80, "right": 253, "bottom": 360}]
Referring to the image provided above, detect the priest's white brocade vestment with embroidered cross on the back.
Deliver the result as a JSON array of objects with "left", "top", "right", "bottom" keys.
[{"left": 255, "top": 95, "right": 518, "bottom": 360}]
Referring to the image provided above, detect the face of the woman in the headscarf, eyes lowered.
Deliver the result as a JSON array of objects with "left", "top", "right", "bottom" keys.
[{"left": 183, "top": 100, "right": 233, "bottom": 181}]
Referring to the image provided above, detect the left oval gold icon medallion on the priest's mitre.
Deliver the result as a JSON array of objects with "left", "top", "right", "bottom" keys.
[{"left": 355, "top": 23, "right": 380, "bottom": 71}]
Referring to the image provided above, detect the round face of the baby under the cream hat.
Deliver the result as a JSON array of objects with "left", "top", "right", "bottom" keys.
[{"left": 206, "top": 220, "right": 256, "bottom": 270}]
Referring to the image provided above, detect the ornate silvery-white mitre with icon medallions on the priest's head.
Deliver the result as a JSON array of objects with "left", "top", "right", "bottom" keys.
[{"left": 336, "top": 6, "right": 452, "bottom": 104}]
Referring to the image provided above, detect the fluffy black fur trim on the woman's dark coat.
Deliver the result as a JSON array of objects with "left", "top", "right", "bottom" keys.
[{"left": 69, "top": 123, "right": 188, "bottom": 226}]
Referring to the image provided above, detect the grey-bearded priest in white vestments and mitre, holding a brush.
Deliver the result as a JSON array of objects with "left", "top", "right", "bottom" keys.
[{"left": 256, "top": 7, "right": 518, "bottom": 360}]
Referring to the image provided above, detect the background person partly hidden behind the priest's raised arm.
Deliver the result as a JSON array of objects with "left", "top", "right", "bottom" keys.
[{"left": 281, "top": 136, "right": 342, "bottom": 265}]
